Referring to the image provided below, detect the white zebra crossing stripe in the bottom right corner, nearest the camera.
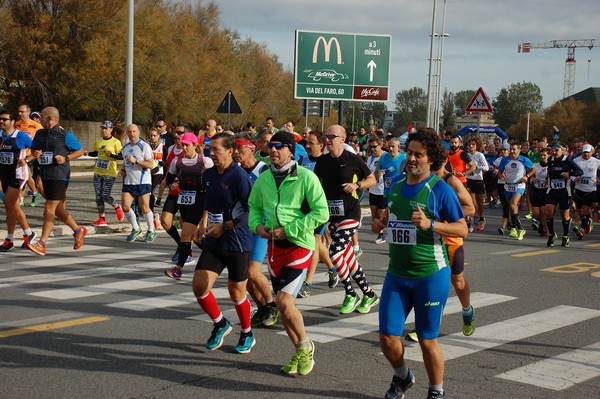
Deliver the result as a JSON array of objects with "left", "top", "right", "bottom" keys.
[{"left": 496, "top": 342, "right": 600, "bottom": 391}]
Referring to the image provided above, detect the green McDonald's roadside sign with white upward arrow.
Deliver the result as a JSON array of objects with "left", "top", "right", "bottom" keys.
[{"left": 294, "top": 30, "right": 392, "bottom": 101}]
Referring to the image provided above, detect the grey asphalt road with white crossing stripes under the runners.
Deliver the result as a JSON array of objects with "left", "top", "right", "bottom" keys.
[{"left": 0, "top": 178, "right": 600, "bottom": 399}]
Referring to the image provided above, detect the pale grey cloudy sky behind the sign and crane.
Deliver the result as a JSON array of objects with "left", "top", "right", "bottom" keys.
[{"left": 215, "top": 0, "right": 600, "bottom": 109}]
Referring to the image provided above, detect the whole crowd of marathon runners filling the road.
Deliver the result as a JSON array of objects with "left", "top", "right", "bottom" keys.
[{"left": 0, "top": 105, "right": 600, "bottom": 398}]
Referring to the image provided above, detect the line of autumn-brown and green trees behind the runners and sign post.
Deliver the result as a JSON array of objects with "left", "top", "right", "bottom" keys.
[{"left": 0, "top": 0, "right": 600, "bottom": 141}]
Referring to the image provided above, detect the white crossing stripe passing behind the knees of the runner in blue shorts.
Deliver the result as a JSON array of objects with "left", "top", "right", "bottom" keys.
[{"left": 292, "top": 292, "right": 517, "bottom": 346}]
